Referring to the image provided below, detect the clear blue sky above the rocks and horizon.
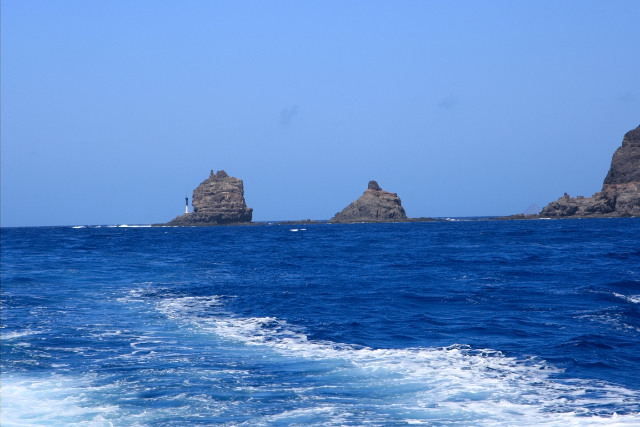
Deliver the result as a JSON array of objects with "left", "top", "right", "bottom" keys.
[{"left": 0, "top": 0, "right": 640, "bottom": 226}]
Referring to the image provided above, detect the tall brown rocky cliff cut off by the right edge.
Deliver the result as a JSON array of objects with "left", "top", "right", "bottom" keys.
[{"left": 540, "top": 126, "right": 640, "bottom": 218}]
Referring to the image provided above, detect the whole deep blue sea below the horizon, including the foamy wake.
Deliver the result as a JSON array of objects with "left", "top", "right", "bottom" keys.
[{"left": 0, "top": 218, "right": 640, "bottom": 426}]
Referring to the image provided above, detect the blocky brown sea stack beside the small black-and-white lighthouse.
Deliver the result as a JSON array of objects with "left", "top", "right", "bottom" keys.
[{"left": 166, "top": 171, "right": 253, "bottom": 226}]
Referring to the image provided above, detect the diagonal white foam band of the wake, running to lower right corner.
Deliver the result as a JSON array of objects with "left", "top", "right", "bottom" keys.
[{"left": 158, "top": 296, "right": 640, "bottom": 425}]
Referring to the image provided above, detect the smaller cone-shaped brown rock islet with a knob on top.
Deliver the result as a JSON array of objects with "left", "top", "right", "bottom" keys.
[{"left": 330, "top": 181, "right": 408, "bottom": 222}]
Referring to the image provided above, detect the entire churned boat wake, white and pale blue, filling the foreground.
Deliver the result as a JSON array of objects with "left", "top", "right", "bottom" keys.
[{"left": 5, "top": 290, "right": 640, "bottom": 426}]
